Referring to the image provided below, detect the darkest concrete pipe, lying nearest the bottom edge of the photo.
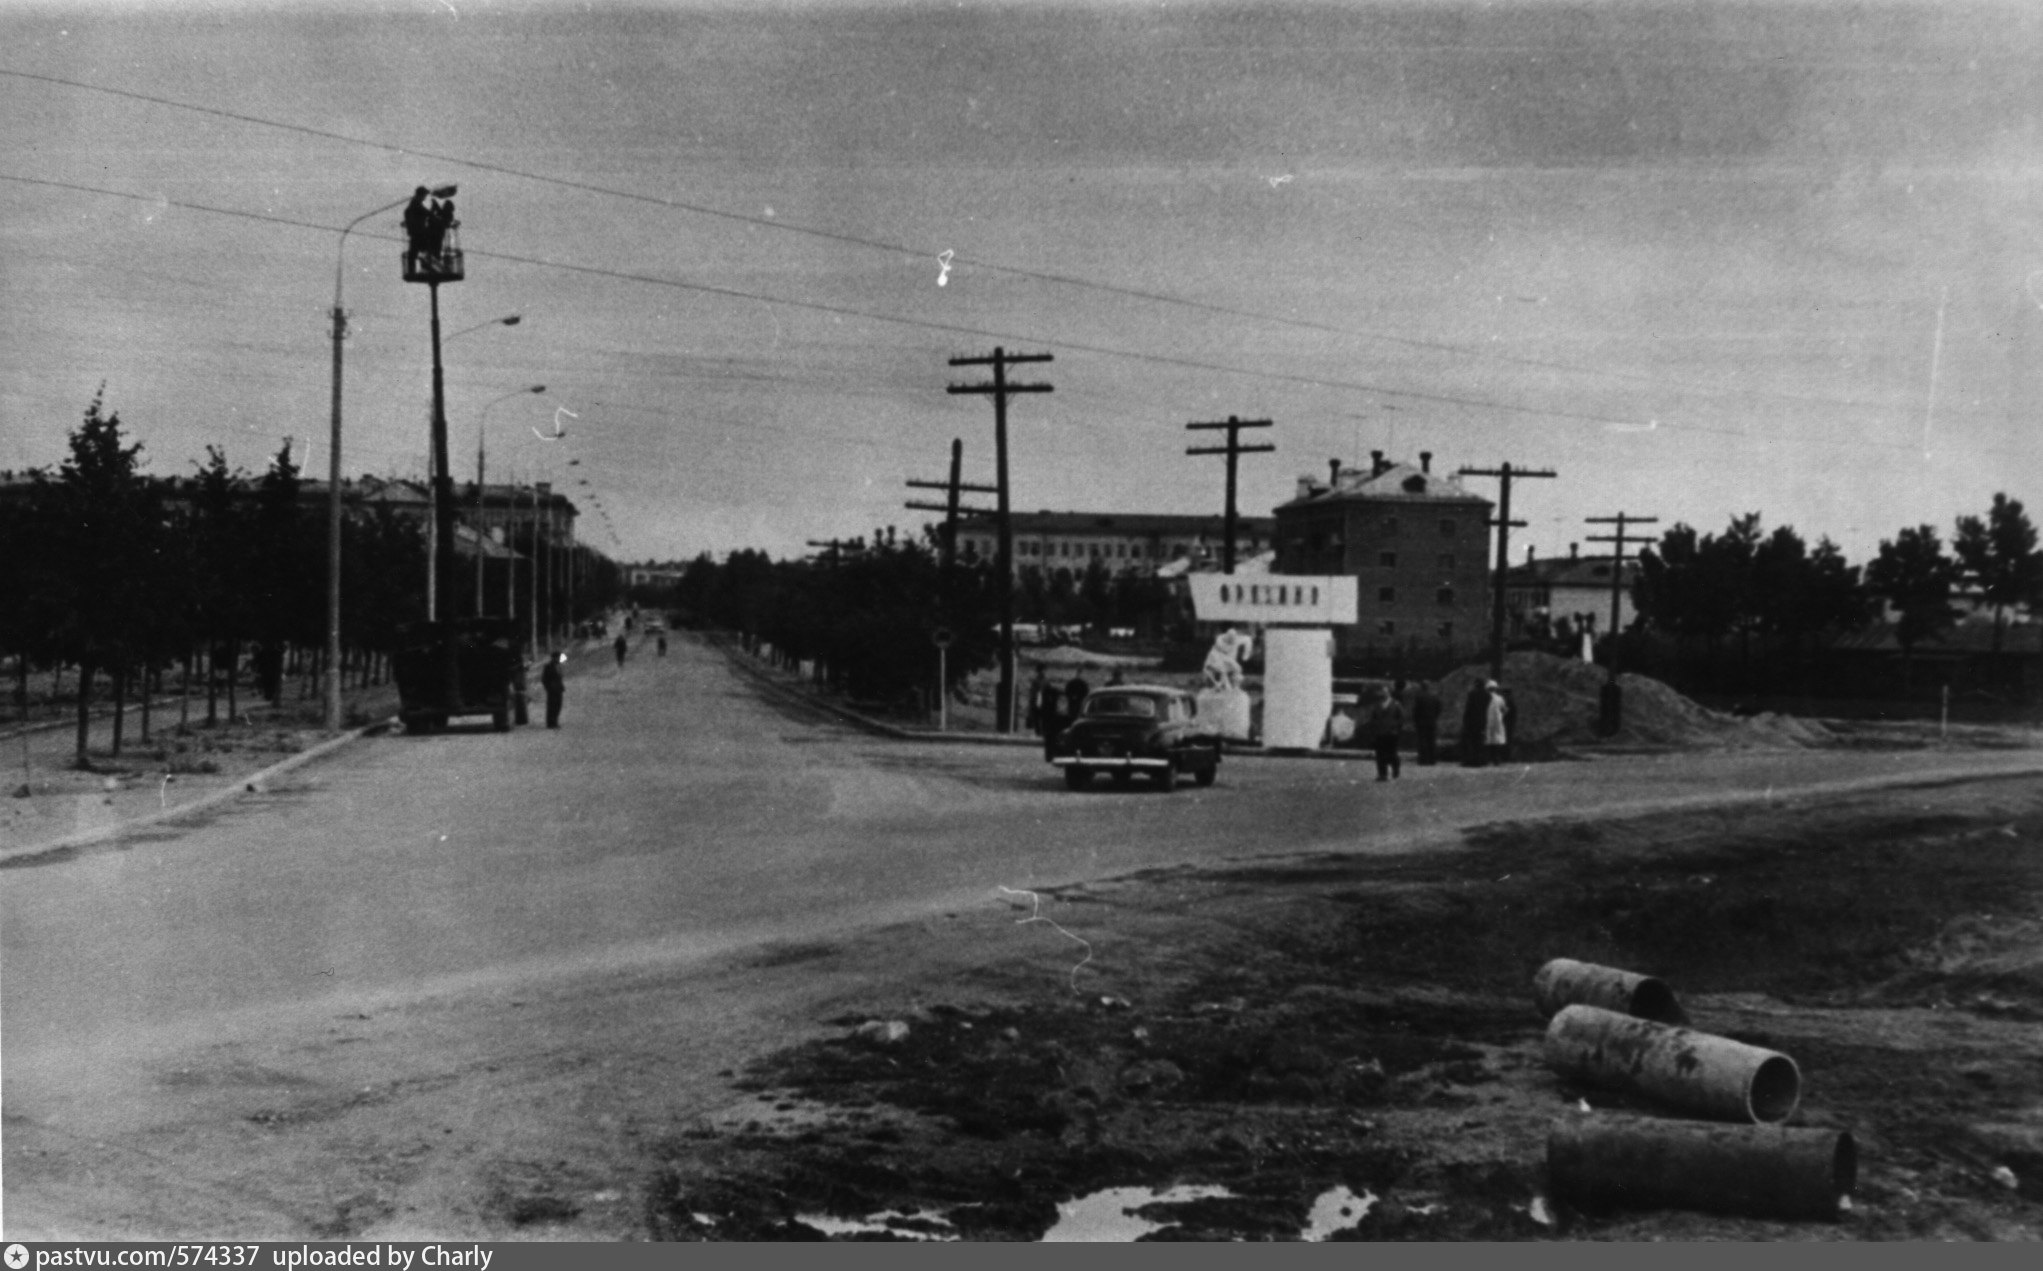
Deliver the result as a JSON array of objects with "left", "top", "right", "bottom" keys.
[{"left": 1547, "top": 1116, "right": 1859, "bottom": 1220}]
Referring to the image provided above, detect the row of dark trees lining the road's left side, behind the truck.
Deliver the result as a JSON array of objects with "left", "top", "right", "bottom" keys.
[{"left": 0, "top": 396, "right": 617, "bottom": 758}]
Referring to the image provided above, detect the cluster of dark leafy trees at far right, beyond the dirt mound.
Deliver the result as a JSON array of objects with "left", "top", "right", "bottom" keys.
[{"left": 1632, "top": 495, "right": 2043, "bottom": 687}]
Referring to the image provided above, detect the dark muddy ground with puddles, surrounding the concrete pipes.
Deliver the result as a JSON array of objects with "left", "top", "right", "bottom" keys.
[{"left": 637, "top": 779, "right": 2043, "bottom": 1240}]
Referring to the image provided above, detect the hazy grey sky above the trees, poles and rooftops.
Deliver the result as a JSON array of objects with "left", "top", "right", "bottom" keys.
[{"left": 0, "top": 0, "right": 2043, "bottom": 562}]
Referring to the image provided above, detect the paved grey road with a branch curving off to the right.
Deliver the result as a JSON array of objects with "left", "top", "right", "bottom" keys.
[{"left": 12, "top": 640, "right": 2043, "bottom": 1112}]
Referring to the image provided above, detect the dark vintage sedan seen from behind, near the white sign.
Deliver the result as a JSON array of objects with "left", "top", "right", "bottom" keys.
[{"left": 1050, "top": 685, "right": 1220, "bottom": 791}]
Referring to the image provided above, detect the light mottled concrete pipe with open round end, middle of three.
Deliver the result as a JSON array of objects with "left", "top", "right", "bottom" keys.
[{"left": 1547, "top": 1005, "right": 1802, "bottom": 1122}]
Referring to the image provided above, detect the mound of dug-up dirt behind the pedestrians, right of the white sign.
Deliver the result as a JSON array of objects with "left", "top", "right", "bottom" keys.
[{"left": 1440, "top": 652, "right": 1831, "bottom": 754}]
